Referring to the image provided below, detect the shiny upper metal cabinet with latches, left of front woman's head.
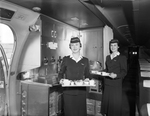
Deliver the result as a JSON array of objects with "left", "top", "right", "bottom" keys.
[{"left": 41, "top": 16, "right": 79, "bottom": 67}]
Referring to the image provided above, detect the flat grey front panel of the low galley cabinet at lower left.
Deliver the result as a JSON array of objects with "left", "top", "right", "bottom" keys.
[{"left": 20, "top": 82, "right": 49, "bottom": 116}]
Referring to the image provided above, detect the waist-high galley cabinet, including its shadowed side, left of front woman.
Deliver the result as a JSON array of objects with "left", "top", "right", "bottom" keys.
[{"left": 20, "top": 81, "right": 62, "bottom": 116}]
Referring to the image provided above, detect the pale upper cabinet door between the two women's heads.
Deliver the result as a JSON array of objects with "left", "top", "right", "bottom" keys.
[{"left": 83, "top": 29, "right": 103, "bottom": 62}]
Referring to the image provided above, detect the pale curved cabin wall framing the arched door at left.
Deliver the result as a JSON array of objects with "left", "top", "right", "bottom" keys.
[{"left": 0, "top": 1, "right": 39, "bottom": 115}]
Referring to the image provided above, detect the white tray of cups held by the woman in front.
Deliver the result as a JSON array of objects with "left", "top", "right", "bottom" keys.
[{"left": 60, "top": 79, "right": 96, "bottom": 87}]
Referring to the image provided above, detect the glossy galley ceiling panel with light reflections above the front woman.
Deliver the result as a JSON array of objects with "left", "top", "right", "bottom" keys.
[{"left": 3, "top": 0, "right": 104, "bottom": 29}]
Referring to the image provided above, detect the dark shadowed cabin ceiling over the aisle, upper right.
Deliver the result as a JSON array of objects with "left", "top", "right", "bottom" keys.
[{"left": 91, "top": 0, "right": 150, "bottom": 48}]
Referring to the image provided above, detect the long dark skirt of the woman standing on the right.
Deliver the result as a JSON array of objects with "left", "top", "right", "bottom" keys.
[{"left": 101, "top": 85, "right": 122, "bottom": 116}]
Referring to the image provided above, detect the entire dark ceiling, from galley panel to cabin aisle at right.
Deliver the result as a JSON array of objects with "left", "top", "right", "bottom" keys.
[{"left": 5, "top": 0, "right": 150, "bottom": 49}]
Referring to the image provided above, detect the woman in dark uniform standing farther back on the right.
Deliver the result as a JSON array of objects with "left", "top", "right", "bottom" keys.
[{"left": 101, "top": 39, "right": 127, "bottom": 116}]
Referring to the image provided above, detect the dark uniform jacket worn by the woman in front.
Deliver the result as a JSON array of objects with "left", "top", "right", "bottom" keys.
[{"left": 58, "top": 56, "right": 90, "bottom": 95}]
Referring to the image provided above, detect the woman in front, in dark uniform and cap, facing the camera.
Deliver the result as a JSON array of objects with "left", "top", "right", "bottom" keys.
[{"left": 58, "top": 37, "right": 90, "bottom": 116}]
